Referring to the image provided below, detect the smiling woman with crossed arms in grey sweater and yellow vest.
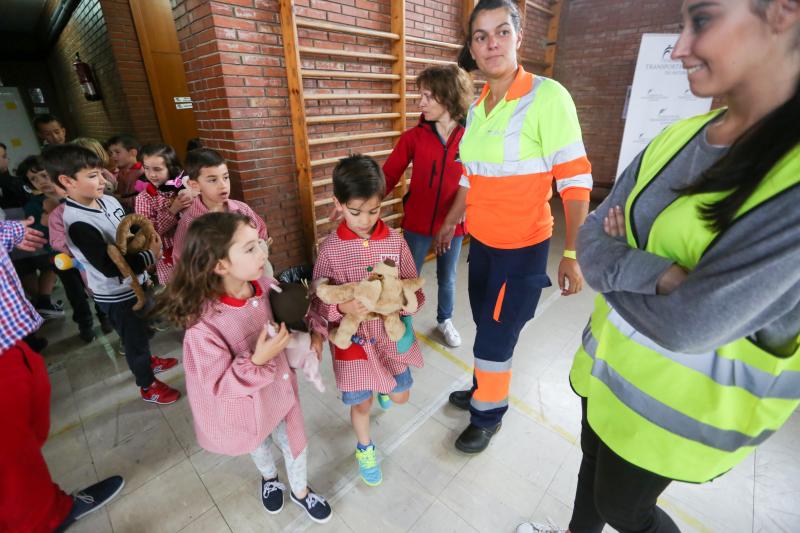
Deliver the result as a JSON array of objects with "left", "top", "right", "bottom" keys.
[{"left": 518, "top": 0, "right": 800, "bottom": 533}]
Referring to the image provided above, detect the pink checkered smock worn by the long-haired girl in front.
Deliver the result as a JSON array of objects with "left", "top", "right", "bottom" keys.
[{"left": 183, "top": 278, "right": 306, "bottom": 457}]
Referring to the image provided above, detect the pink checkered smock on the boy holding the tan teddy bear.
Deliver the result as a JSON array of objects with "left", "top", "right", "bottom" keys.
[{"left": 309, "top": 221, "right": 425, "bottom": 393}]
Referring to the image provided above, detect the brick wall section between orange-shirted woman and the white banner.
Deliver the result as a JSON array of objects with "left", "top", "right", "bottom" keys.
[{"left": 554, "top": 0, "right": 681, "bottom": 196}]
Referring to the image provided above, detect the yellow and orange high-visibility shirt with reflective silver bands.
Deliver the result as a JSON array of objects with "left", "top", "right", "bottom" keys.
[{"left": 458, "top": 67, "right": 592, "bottom": 249}]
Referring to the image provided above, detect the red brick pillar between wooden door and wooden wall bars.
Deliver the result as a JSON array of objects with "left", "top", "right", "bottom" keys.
[{"left": 172, "top": 0, "right": 306, "bottom": 269}]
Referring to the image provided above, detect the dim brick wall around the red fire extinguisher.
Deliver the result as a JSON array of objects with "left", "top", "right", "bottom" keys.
[{"left": 47, "top": 0, "right": 161, "bottom": 142}]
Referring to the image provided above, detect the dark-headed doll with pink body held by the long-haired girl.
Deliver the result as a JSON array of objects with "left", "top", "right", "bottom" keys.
[{"left": 267, "top": 282, "right": 325, "bottom": 392}]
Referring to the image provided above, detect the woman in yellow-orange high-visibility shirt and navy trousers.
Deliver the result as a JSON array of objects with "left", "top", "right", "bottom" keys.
[{"left": 440, "top": 0, "right": 592, "bottom": 453}]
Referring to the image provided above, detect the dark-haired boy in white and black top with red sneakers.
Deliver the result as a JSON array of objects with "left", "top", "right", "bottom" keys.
[{"left": 42, "top": 145, "right": 180, "bottom": 404}]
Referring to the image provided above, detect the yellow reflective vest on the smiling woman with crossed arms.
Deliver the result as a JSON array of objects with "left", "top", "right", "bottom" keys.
[{"left": 570, "top": 110, "right": 800, "bottom": 482}]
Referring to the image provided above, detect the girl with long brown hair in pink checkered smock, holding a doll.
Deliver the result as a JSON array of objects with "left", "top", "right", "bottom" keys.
[{"left": 157, "top": 213, "right": 331, "bottom": 523}]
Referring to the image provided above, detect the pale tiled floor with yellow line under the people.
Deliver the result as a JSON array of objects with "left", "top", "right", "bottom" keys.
[{"left": 43, "top": 207, "right": 800, "bottom": 533}]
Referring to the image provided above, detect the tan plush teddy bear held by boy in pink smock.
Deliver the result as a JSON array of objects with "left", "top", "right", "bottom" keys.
[{"left": 316, "top": 259, "right": 425, "bottom": 350}]
